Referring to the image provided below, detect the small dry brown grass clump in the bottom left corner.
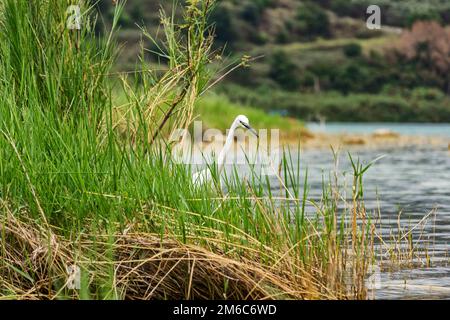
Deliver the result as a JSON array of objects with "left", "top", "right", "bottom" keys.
[{"left": 0, "top": 201, "right": 71, "bottom": 299}]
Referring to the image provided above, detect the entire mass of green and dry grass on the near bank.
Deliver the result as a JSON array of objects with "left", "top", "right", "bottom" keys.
[{"left": 0, "top": 0, "right": 384, "bottom": 299}]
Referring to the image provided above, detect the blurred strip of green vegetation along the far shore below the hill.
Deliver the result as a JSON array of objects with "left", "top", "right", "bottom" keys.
[{"left": 219, "top": 85, "right": 450, "bottom": 123}]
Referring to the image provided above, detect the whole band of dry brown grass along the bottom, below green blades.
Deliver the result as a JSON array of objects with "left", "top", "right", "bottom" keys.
[{"left": 0, "top": 202, "right": 362, "bottom": 300}]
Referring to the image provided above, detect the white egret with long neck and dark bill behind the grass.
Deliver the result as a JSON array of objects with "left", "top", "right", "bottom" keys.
[{"left": 192, "top": 115, "right": 259, "bottom": 186}]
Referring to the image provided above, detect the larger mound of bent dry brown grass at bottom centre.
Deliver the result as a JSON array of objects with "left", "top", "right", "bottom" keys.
[{"left": 117, "top": 235, "right": 324, "bottom": 300}]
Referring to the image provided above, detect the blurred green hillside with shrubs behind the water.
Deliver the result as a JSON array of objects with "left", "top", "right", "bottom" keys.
[{"left": 98, "top": 0, "right": 450, "bottom": 122}]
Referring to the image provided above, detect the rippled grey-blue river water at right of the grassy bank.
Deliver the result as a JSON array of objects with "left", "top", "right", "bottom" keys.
[{"left": 301, "top": 123, "right": 450, "bottom": 299}]
